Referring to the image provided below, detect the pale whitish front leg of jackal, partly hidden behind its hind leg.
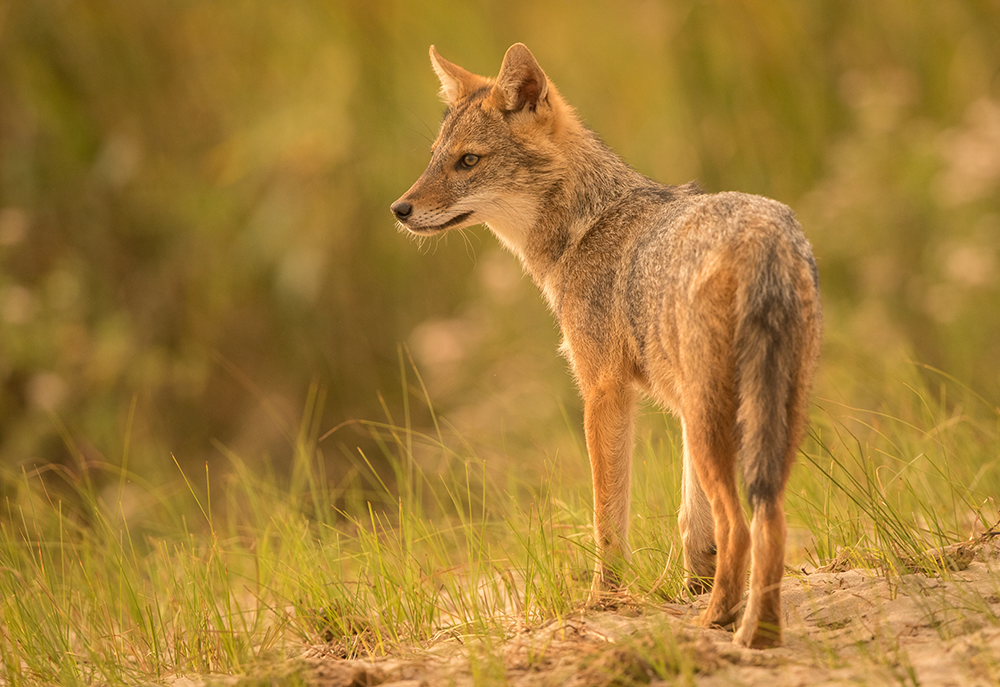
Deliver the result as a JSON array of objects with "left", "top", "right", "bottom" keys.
[{"left": 677, "top": 422, "right": 716, "bottom": 594}]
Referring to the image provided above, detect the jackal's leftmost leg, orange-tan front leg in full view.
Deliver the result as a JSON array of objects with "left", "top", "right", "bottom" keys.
[{"left": 583, "top": 380, "right": 635, "bottom": 605}]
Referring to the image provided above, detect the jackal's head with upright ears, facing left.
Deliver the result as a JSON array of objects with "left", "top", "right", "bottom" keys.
[{"left": 392, "top": 43, "right": 572, "bottom": 252}]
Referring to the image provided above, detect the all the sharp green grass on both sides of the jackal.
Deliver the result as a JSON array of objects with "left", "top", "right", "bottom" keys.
[{"left": 0, "top": 362, "right": 1000, "bottom": 685}]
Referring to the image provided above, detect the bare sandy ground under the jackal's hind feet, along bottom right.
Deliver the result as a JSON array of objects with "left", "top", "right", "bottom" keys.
[{"left": 286, "top": 533, "right": 1000, "bottom": 687}]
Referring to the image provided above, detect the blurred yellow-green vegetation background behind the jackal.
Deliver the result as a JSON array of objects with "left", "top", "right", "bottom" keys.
[{"left": 0, "top": 0, "right": 1000, "bottom": 494}]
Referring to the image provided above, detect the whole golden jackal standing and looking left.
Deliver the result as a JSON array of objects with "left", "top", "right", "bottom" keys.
[{"left": 392, "top": 43, "right": 821, "bottom": 647}]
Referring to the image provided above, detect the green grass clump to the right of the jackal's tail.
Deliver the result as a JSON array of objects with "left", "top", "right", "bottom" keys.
[{"left": 788, "top": 367, "right": 1000, "bottom": 574}]
